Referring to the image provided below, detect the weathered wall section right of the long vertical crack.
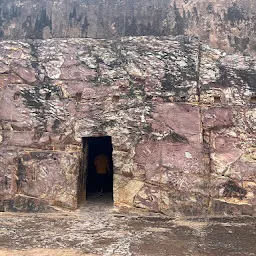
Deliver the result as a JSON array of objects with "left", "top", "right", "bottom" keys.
[{"left": 200, "top": 46, "right": 256, "bottom": 214}]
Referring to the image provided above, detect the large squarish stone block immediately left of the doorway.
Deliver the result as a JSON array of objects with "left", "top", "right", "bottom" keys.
[{"left": 17, "top": 151, "right": 79, "bottom": 208}]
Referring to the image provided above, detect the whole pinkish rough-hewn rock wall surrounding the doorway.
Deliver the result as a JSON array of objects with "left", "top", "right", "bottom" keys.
[{"left": 0, "top": 37, "right": 256, "bottom": 216}]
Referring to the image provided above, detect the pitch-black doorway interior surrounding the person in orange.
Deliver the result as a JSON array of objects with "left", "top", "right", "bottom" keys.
[{"left": 81, "top": 136, "right": 113, "bottom": 200}]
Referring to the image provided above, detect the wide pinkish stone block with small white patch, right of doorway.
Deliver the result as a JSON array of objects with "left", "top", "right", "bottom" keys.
[{"left": 134, "top": 138, "right": 205, "bottom": 185}]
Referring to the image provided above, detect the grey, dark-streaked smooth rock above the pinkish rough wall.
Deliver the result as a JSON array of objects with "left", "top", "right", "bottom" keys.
[{"left": 0, "top": 0, "right": 256, "bottom": 54}]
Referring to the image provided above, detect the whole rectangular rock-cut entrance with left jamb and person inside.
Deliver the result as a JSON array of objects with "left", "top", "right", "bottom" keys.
[{"left": 78, "top": 136, "right": 113, "bottom": 206}]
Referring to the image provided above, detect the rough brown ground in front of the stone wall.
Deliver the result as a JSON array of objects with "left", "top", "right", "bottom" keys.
[{"left": 0, "top": 194, "right": 256, "bottom": 256}]
